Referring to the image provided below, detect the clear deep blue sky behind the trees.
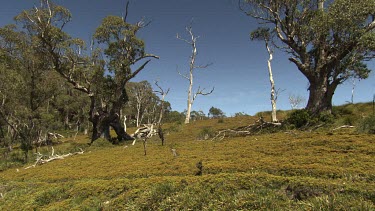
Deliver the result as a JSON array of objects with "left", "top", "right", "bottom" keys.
[{"left": 0, "top": 0, "right": 375, "bottom": 116}]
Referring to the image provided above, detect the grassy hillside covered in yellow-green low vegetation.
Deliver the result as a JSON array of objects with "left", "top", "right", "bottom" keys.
[{"left": 0, "top": 104, "right": 375, "bottom": 210}]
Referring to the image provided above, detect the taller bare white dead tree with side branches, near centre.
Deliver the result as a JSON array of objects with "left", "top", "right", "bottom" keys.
[{"left": 177, "top": 24, "right": 215, "bottom": 124}]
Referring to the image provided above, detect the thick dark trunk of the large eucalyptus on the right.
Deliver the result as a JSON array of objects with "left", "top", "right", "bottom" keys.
[{"left": 306, "top": 77, "right": 338, "bottom": 115}]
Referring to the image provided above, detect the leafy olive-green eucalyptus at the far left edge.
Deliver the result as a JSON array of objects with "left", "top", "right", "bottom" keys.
[{"left": 0, "top": 25, "right": 61, "bottom": 160}]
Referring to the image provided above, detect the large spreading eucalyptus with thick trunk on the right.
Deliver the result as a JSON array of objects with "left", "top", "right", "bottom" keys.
[{"left": 240, "top": 0, "right": 375, "bottom": 115}]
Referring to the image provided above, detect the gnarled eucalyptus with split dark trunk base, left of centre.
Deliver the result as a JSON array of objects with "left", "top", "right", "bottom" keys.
[{"left": 16, "top": 0, "right": 158, "bottom": 143}]
